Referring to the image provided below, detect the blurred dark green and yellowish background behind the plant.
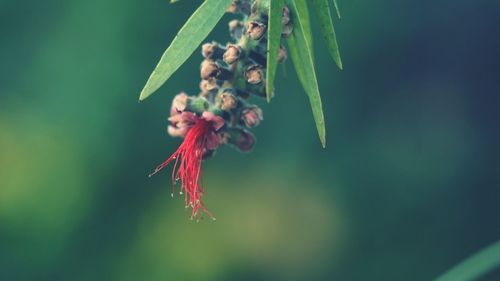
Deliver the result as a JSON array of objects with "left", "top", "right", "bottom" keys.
[{"left": 0, "top": 0, "right": 500, "bottom": 281}]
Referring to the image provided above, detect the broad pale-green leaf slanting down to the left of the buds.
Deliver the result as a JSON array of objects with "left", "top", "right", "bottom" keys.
[{"left": 139, "top": 0, "right": 232, "bottom": 101}]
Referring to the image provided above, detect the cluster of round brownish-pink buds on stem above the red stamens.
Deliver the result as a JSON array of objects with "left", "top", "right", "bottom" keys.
[{"left": 168, "top": 0, "right": 293, "bottom": 157}]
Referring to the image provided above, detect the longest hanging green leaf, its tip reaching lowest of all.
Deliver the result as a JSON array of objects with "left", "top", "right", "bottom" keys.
[{"left": 287, "top": 0, "right": 326, "bottom": 147}]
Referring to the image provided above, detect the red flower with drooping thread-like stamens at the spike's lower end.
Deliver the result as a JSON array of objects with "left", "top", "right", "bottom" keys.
[{"left": 150, "top": 111, "right": 224, "bottom": 218}]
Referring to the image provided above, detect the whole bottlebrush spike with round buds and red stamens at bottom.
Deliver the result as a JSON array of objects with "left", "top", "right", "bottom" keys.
[{"left": 145, "top": 0, "right": 292, "bottom": 219}]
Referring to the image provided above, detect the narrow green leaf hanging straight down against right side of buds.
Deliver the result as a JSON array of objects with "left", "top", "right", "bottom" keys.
[{"left": 266, "top": 0, "right": 284, "bottom": 102}]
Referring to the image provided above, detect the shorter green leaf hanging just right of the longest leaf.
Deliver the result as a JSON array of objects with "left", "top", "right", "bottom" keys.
[{"left": 311, "top": 0, "right": 342, "bottom": 69}]
